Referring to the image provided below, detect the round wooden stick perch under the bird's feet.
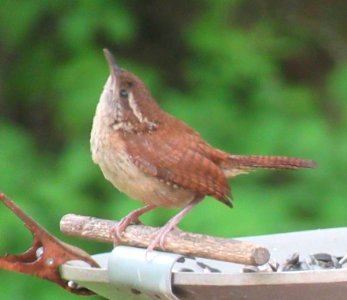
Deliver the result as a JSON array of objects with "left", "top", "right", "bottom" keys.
[{"left": 60, "top": 214, "right": 270, "bottom": 266}]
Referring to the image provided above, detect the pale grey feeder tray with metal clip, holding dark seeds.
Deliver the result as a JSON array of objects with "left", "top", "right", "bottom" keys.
[{"left": 61, "top": 228, "right": 347, "bottom": 300}]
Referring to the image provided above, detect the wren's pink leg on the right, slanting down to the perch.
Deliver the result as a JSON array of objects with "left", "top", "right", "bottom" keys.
[{"left": 146, "top": 196, "right": 203, "bottom": 255}]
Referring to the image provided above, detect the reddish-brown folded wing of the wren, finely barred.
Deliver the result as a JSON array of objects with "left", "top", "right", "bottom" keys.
[{"left": 125, "top": 123, "right": 231, "bottom": 206}]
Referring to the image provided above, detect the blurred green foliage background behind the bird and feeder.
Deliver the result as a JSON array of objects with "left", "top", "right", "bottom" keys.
[{"left": 0, "top": 0, "right": 347, "bottom": 300}]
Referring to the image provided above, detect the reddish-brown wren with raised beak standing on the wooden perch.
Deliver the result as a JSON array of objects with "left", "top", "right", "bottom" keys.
[{"left": 90, "top": 49, "right": 315, "bottom": 251}]
